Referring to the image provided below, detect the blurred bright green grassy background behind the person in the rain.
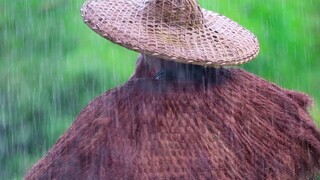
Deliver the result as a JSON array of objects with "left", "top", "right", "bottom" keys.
[{"left": 0, "top": 0, "right": 320, "bottom": 179}]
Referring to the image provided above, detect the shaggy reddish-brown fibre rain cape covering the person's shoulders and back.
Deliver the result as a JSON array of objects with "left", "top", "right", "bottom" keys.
[{"left": 26, "top": 67, "right": 320, "bottom": 179}]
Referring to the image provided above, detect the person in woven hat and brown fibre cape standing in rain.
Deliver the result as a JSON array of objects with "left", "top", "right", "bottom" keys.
[{"left": 25, "top": 0, "right": 320, "bottom": 179}]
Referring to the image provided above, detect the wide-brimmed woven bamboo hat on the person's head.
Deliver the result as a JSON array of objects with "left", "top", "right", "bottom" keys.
[{"left": 81, "top": 0, "right": 259, "bottom": 66}]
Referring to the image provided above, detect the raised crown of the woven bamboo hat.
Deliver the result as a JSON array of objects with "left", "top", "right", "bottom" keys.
[{"left": 149, "top": 0, "right": 203, "bottom": 28}]
